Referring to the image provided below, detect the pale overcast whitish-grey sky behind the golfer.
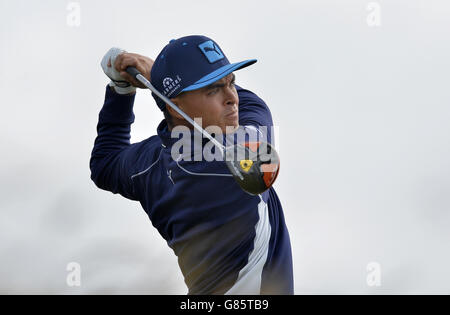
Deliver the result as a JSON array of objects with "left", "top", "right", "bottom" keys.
[{"left": 0, "top": 0, "right": 450, "bottom": 294}]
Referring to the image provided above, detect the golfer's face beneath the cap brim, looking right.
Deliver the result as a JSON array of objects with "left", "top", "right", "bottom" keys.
[{"left": 171, "top": 73, "right": 239, "bottom": 133}]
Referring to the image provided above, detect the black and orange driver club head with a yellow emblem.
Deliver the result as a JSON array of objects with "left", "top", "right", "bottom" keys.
[{"left": 225, "top": 141, "right": 280, "bottom": 195}]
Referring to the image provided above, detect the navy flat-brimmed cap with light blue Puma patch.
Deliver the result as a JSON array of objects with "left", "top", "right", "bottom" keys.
[{"left": 150, "top": 35, "right": 256, "bottom": 110}]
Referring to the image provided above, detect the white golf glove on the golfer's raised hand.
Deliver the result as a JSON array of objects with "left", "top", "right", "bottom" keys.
[{"left": 101, "top": 47, "right": 136, "bottom": 94}]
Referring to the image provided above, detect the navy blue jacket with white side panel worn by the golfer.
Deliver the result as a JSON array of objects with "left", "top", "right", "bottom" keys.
[{"left": 90, "top": 86, "right": 293, "bottom": 294}]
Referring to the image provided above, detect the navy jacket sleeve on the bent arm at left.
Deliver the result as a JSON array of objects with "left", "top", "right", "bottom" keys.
[{"left": 89, "top": 86, "right": 142, "bottom": 200}]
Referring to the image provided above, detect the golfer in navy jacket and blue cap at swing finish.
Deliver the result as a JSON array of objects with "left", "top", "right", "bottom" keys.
[{"left": 90, "top": 35, "right": 293, "bottom": 294}]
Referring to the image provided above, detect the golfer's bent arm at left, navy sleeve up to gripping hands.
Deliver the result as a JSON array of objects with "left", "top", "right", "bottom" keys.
[{"left": 89, "top": 48, "right": 153, "bottom": 200}]
